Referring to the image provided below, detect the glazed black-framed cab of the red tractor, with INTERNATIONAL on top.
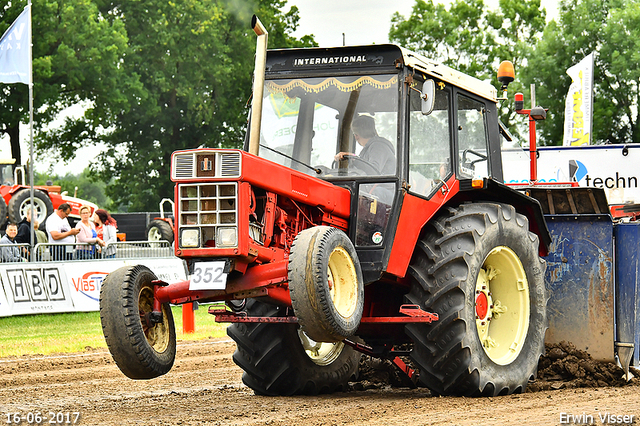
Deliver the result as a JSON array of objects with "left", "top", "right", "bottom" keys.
[{"left": 250, "top": 45, "right": 502, "bottom": 281}]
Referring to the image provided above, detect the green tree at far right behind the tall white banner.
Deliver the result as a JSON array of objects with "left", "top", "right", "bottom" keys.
[{"left": 528, "top": 0, "right": 640, "bottom": 145}]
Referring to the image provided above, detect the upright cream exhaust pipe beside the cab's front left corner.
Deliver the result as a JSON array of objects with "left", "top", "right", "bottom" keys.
[{"left": 249, "top": 15, "right": 269, "bottom": 155}]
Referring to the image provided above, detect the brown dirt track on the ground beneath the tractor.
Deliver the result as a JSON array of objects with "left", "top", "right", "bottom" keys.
[{"left": 0, "top": 339, "right": 640, "bottom": 426}]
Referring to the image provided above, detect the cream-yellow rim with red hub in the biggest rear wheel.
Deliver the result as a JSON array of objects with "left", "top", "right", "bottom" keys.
[{"left": 474, "top": 246, "right": 531, "bottom": 365}]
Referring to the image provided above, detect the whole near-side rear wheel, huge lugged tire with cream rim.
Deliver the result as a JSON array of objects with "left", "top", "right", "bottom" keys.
[{"left": 406, "top": 203, "right": 547, "bottom": 396}]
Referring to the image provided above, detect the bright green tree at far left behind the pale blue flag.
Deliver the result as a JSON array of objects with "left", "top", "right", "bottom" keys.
[{"left": 0, "top": 0, "right": 140, "bottom": 163}]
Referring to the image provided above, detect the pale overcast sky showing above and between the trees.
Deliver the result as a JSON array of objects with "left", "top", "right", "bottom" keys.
[{"left": 0, "top": 0, "right": 557, "bottom": 175}]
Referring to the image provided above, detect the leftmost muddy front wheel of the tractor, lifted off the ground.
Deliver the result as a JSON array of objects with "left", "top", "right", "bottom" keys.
[{"left": 100, "top": 265, "right": 176, "bottom": 379}]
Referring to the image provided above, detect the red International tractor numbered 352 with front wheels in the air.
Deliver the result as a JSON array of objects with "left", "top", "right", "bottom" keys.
[{"left": 100, "top": 16, "right": 550, "bottom": 395}]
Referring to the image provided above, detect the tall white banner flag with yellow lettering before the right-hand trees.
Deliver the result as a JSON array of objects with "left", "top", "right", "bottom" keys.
[{"left": 562, "top": 52, "right": 593, "bottom": 146}]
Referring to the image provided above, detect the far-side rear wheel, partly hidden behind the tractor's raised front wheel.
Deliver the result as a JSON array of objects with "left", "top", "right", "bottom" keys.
[{"left": 227, "top": 299, "right": 361, "bottom": 396}]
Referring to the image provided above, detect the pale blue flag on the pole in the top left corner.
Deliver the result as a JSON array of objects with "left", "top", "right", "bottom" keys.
[{"left": 0, "top": 6, "right": 31, "bottom": 84}]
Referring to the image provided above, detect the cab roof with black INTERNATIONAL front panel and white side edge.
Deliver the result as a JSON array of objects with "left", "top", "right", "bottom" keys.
[{"left": 266, "top": 44, "right": 497, "bottom": 102}]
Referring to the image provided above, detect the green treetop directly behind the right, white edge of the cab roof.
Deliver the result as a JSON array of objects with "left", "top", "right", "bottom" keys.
[{"left": 389, "top": 0, "right": 546, "bottom": 129}]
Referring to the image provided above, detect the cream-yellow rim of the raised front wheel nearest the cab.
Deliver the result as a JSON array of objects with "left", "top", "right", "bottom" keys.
[{"left": 327, "top": 247, "right": 358, "bottom": 318}]
